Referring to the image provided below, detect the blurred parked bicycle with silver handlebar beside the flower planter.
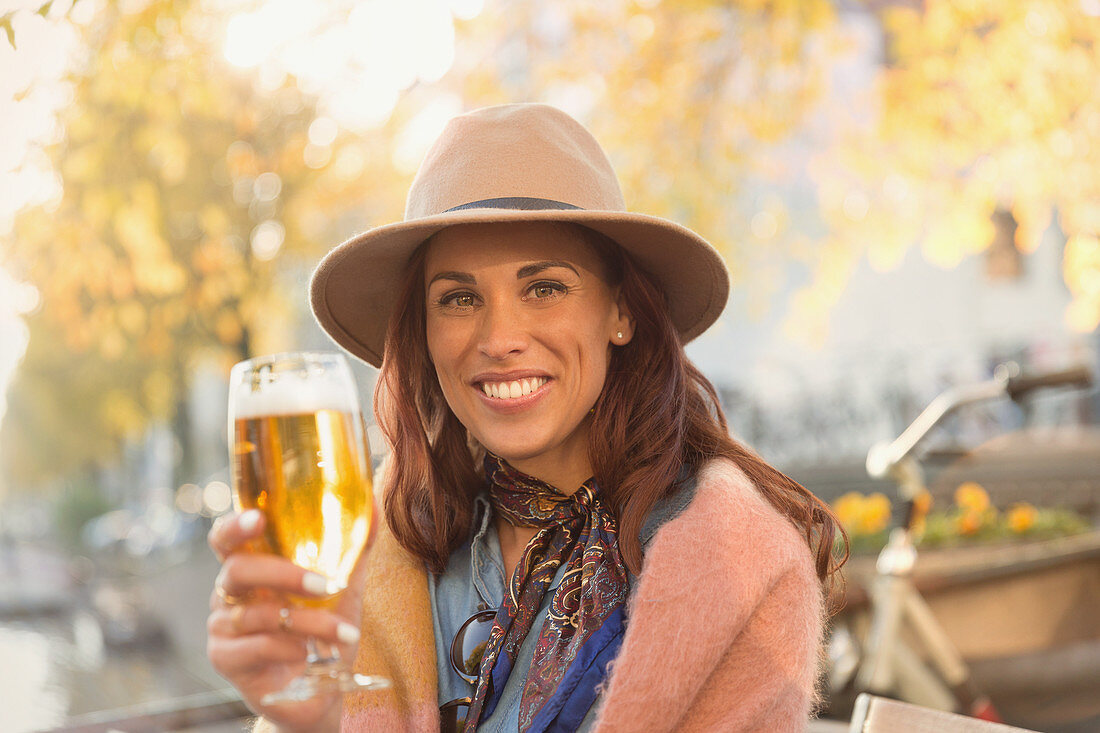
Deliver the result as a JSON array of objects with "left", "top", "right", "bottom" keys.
[{"left": 829, "top": 362, "right": 1092, "bottom": 722}]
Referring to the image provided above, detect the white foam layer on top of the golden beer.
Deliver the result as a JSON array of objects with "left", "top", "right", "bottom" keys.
[{"left": 233, "top": 374, "right": 358, "bottom": 419}]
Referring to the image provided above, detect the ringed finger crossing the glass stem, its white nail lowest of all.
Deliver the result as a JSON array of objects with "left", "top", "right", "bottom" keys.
[{"left": 207, "top": 603, "right": 359, "bottom": 645}]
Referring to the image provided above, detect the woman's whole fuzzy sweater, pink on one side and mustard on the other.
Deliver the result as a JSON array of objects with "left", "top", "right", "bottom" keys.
[{"left": 334, "top": 460, "right": 824, "bottom": 733}]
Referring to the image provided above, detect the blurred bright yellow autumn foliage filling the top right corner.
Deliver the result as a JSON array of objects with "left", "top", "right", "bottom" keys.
[{"left": 795, "top": 0, "right": 1100, "bottom": 343}]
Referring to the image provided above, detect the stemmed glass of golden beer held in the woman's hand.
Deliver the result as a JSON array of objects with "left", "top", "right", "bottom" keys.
[{"left": 229, "top": 352, "right": 389, "bottom": 704}]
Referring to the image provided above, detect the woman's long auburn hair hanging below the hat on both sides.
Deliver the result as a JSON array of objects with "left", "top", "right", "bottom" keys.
[{"left": 374, "top": 221, "right": 848, "bottom": 581}]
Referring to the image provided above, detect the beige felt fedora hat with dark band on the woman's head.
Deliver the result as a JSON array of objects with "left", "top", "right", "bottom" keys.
[{"left": 310, "top": 103, "right": 729, "bottom": 367}]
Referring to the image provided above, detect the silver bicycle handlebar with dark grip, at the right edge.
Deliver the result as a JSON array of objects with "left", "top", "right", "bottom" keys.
[{"left": 867, "top": 362, "right": 1092, "bottom": 479}]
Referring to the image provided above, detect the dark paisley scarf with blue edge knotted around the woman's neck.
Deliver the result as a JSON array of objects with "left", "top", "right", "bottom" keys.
[{"left": 465, "top": 453, "right": 628, "bottom": 733}]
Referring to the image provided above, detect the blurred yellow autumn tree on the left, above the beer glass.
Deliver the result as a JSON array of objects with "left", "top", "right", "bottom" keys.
[{"left": 2, "top": 0, "right": 398, "bottom": 485}]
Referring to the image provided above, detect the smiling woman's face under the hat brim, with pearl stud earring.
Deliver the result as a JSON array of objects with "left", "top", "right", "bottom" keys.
[{"left": 425, "top": 222, "right": 633, "bottom": 491}]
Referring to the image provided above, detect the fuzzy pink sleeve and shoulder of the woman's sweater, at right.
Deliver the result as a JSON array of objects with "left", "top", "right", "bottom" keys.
[{"left": 598, "top": 460, "right": 823, "bottom": 731}]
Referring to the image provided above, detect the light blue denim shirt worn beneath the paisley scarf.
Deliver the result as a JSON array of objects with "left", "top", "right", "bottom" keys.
[{"left": 428, "top": 477, "right": 695, "bottom": 733}]
